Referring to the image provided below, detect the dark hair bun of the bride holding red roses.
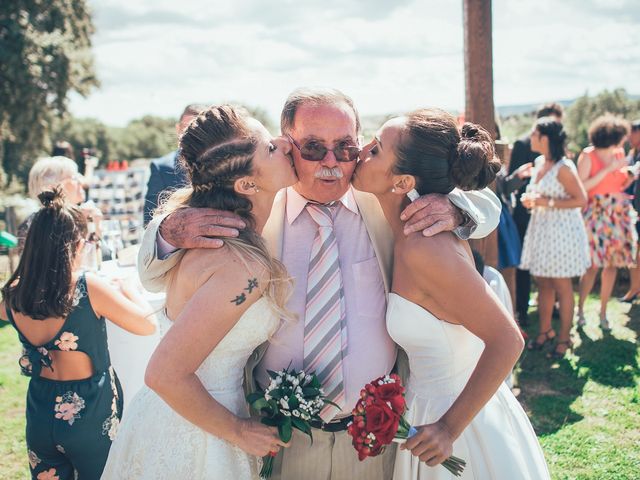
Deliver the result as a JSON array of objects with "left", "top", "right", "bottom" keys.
[{"left": 449, "top": 123, "right": 502, "bottom": 190}]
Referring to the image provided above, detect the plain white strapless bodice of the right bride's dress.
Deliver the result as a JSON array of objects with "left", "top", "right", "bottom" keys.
[{"left": 387, "top": 293, "right": 484, "bottom": 396}]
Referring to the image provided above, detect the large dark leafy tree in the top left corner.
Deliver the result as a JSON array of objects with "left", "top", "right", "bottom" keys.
[{"left": 0, "top": 0, "right": 98, "bottom": 184}]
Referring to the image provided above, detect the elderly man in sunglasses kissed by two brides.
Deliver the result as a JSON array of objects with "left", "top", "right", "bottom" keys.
[{"left": 139, "top": 89, "right": 500, "bottom": 480}]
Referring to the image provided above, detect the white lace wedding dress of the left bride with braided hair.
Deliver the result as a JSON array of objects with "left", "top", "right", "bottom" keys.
[{"left": 101, "top": 297, "right": 278, "bottom": 480}]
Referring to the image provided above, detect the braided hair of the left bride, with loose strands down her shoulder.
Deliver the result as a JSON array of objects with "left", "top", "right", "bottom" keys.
[{"left": 159, "top": 105, "right": 291, "bottom": 318}]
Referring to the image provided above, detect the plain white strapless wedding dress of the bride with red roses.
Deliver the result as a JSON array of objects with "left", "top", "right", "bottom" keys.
[{"left": 387, "top": 293, "right": 550, "bottom": 480}]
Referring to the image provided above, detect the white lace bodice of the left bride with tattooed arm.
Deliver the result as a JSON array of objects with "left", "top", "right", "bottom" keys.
[{"left": 160, "top": 297, "right": 279, "bottom": 396}]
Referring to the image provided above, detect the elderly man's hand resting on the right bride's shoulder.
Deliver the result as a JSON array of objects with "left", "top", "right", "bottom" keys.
[{"left": 402, "top": 193, "right": 463, "bottom": 237}]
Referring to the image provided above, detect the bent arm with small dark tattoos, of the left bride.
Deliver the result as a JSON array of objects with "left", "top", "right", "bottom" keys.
[{"left": 145, "top": 259, "right": 283, "bottom": 456}]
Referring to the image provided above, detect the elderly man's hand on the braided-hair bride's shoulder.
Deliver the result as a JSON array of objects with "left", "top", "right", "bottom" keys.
[{"left": 160, "top": 208, "right": 246, "bottom": 249}]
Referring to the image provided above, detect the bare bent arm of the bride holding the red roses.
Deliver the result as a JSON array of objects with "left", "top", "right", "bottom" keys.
[{"left": 399, "top": 234, "right": 524, "bottom": 465}]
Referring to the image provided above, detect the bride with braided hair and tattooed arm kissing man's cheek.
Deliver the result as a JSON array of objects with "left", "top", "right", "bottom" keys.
[{"left": 102, "top": 105, "right": 297, "bottom": 480}]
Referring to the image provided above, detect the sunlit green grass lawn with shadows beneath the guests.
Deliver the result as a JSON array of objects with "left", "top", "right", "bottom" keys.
[{"left": 0, "top": 297, "right": 640, "bottom": 480}]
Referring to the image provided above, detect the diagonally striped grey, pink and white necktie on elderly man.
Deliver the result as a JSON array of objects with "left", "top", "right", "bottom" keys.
[{"left": 304, "top": 203, "right": 347, "bottom": 422}]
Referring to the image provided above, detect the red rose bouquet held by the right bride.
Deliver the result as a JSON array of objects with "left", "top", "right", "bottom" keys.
[{"left": 347, "top": 374, "right": 466, "bottom": 476}]
